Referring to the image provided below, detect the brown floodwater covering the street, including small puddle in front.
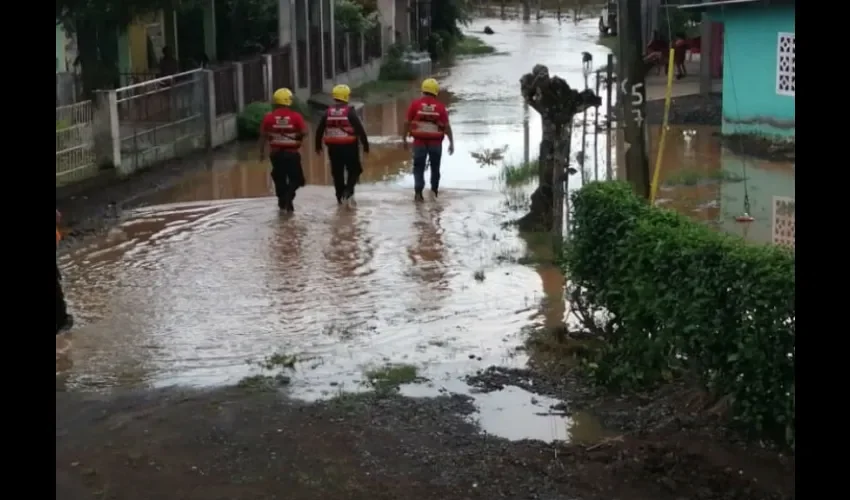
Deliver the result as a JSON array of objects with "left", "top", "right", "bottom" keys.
[{"left": 57, "top": 20, "right": 606, "bottom": 440}]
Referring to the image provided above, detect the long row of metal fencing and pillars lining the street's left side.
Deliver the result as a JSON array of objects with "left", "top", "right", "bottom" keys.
[{"left": 51, "top": 35, "right": 381, "bottom": 186}]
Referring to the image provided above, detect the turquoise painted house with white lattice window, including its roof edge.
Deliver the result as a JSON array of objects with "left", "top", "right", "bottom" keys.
[{"left": 681, "top": 0, "right": 796, "bottom": 140}]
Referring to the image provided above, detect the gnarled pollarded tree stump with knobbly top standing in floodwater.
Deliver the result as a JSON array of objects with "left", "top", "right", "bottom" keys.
[{"left": 518, "top": 64, "right": 602, "bottom": 231}]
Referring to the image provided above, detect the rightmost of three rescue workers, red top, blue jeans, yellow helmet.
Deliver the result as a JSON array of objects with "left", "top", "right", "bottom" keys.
[{"left": 401, "top": 78, "right": 455, "bottom": 201}]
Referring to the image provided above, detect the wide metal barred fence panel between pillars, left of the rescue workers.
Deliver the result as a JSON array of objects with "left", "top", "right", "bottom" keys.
[{"left": 115, "top": 69, "right": 207, "bottom": 171}]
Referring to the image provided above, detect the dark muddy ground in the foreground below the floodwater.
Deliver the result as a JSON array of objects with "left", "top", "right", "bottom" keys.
[{"left": 56, "top": 376, "right": 794, "bottom": 500}]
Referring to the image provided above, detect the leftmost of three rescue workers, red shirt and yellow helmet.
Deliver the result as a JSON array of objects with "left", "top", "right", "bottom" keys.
[{"left": 260, "top": 88, "right": 307, "bottom": 213}]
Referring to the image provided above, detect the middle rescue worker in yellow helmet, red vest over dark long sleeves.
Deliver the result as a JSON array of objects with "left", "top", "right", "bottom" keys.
[{"left": 316, "top": 85, "right": 369, "bottom": 204}]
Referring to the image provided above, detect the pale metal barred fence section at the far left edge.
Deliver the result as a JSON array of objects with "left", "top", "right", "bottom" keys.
[{"left": 56, "top": 101, "right": 97, "bottom": 186}]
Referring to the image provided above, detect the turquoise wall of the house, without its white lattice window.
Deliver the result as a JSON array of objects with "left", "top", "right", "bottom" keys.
[{"left": 711, "top": 5, "right": 795, "bottom": 138}]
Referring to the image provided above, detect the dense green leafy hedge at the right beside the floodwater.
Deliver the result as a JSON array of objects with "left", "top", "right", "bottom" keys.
[{"left": 563, "top": 182, "right": 796, "bottom": 446}]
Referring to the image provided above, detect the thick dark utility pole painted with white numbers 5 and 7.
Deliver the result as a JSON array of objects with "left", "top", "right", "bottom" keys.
[{"left": 617, "top": 0, "right": 650, "bottom": 199}]
